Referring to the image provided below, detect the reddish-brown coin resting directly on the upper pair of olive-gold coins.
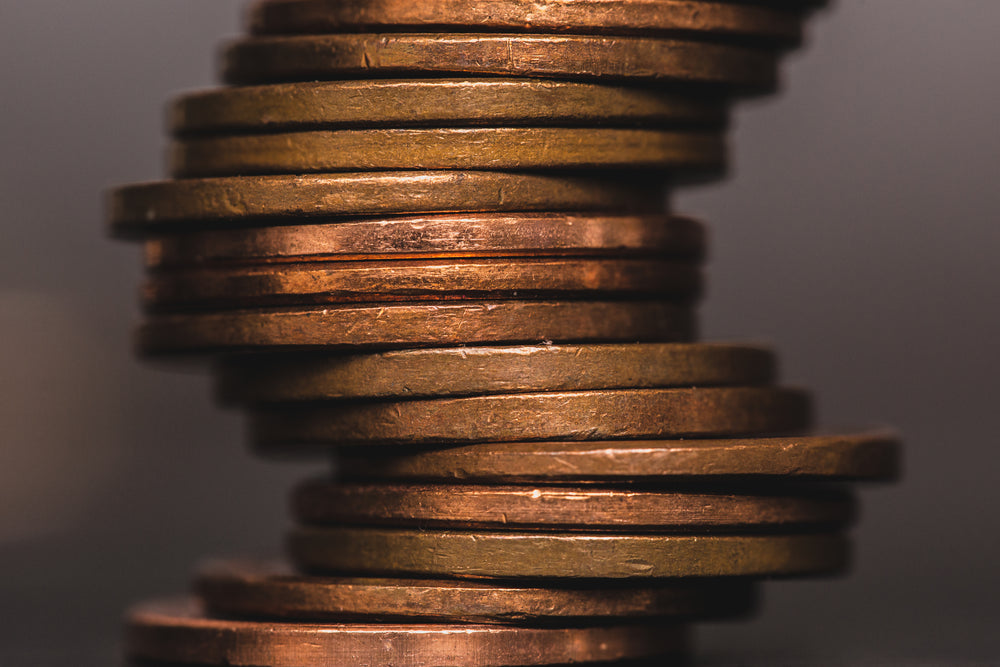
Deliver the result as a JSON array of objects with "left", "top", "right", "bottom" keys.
[{"left": 223, "top": 33, "right": 777, "bottom": 90}]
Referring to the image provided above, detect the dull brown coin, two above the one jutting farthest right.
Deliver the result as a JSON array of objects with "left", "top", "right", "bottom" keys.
[{"left": 218, "top": 343, "right": 775, "bottom": 404}]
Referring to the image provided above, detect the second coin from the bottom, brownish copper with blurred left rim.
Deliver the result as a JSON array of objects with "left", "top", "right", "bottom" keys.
[{"left": 197, "top": 561, "right": 757, "bottom": 624}]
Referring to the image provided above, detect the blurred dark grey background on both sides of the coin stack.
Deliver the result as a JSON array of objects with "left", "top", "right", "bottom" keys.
[{"left": 0, "top": 0, "right": 1000, "bottom": 665}]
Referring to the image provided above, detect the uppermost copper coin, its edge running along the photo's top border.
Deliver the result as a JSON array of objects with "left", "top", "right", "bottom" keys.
[{"left": 250, "top": 0, "right": 802, "bottom": 44}]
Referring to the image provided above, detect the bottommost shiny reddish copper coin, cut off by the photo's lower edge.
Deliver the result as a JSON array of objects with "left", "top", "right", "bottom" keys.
[{"left": 126, "top": 600, "right": 685, "bottom": 667}]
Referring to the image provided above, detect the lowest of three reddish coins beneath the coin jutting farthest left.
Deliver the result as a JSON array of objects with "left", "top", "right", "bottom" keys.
[{"left": 139, "top": 301, "right": 694, "bottom": 355}]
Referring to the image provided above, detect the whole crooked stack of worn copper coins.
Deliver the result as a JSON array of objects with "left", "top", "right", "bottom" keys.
[{"left": 111, "top": 0, "right": 898, "bottom": 667}]
